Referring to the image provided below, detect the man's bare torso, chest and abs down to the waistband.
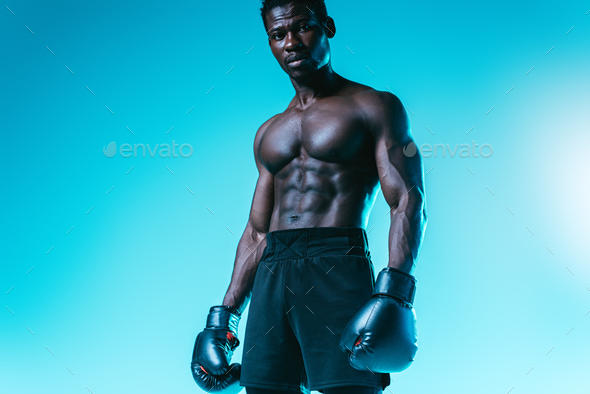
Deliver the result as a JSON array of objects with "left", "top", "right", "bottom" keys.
[{"left": 259, "top": 79, "right": 379, "bottom": 231}]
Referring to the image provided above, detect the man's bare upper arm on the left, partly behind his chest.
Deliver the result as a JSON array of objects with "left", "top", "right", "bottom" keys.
[{"left": 248, "top": 117, "right": 274, "bottom": 240}]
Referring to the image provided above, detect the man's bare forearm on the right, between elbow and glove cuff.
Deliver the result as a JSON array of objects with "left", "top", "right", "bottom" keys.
[{"left": 387, "top": 187, "right": 427, "bottom": 274}]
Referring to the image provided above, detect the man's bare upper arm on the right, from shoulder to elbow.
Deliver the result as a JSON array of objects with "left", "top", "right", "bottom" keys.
[{"left": 368, "top": 92, "right": 426, "bottom": 219}]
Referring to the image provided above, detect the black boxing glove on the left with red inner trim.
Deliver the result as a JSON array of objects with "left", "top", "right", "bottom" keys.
[{"left": 191, "top": 305, "right": 243, "bottom": 394}]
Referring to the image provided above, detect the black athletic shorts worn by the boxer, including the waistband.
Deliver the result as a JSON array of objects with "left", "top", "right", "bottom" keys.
[{"left": 240, "top": 227, "right": 390, "bottom": 392}]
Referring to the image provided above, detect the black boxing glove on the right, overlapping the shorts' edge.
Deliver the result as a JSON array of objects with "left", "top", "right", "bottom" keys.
[{"left": 340, "top": 267, "right": 418, "bottom": 373}]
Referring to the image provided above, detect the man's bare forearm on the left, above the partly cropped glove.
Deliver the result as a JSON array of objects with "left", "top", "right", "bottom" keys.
[{"left": 223, "top": 224, "right": 266, "bottom": 313}]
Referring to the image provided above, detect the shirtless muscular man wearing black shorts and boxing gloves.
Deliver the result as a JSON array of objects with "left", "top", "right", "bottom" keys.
[{"left": 191, "top": 0, "right": 426, "bottom": 394}]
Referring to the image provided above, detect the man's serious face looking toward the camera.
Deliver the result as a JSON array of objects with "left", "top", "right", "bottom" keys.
[{"left": 266, "top": 3, "right": 333, "bottom": 82}]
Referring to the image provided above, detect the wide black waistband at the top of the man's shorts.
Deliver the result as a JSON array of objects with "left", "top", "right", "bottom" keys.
[{"left": 261, "top": 227, "right": 371, "bottom": 261}]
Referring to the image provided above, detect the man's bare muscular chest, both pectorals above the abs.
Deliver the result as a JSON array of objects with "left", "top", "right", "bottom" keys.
[{"left": 260, "top": 103, "right": 372, "bottom": 175}]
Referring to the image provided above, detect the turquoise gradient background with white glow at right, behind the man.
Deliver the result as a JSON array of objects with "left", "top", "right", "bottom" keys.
[{"left": 0, "top": 0, "right": 590, "bottom": 394}]
